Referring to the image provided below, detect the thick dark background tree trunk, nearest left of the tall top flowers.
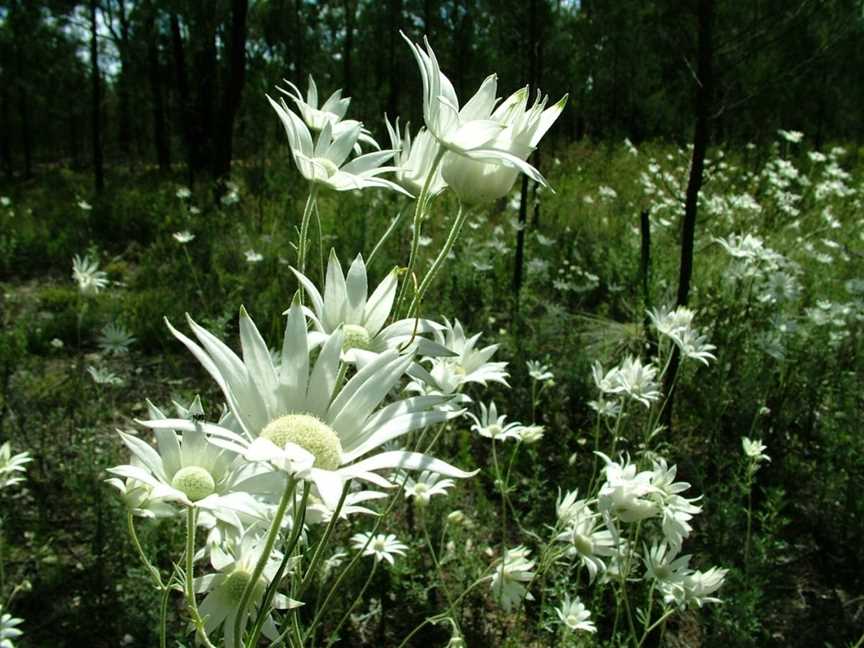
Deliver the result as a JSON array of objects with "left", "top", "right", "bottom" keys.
[{"left": 213, "top": 0, "right": 249, "bottom": 177}]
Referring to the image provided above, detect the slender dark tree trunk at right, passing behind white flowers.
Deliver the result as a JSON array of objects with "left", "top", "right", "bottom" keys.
[{"left": 663, "top": 0, "right": 714, "bottom": 427}]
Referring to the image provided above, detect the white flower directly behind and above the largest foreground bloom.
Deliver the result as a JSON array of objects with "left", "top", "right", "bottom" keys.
[{"left": 292, "top": 250, "right": 451, "bottom": 363}]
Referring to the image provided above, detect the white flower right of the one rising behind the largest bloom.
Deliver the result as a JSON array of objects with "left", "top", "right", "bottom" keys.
[{"left": 410, "top": 319, "right": 509, "bottom": 395}]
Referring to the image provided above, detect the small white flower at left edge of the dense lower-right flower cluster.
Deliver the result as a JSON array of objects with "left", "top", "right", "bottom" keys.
[{"left": 555, "top": 491, "right": 618, "bottom": 581}]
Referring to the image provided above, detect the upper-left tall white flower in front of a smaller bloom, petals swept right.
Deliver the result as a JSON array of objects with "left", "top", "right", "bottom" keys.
[{"left": 267, "top": 97, "right": 410, "bottom": 196}]
